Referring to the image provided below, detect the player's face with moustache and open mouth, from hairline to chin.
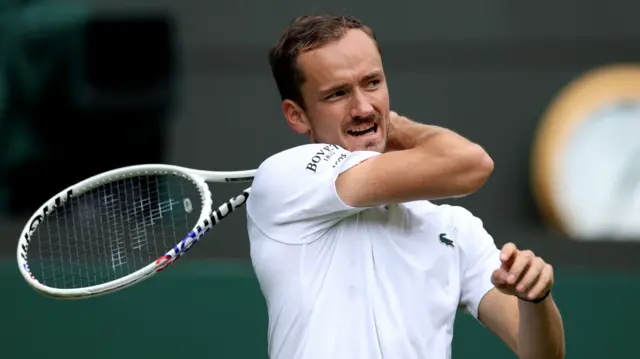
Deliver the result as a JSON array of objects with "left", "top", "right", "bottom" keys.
[{"left": 298, "top": 30, "right": 389, "bottom": 152}]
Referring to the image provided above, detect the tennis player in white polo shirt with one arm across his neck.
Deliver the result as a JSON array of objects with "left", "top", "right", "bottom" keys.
[{"left": 247, "top": 15, "right": 565, "bottom": 359}]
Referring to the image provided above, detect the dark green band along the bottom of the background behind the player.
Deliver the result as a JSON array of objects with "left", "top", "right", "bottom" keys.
[{"left": 0, "top": 260, "right": 640, "bottom": 359}]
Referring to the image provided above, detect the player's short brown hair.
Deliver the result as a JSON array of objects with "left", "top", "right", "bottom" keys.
[{"left": 269, "top": 15, "right": 380, "bottom": 108}]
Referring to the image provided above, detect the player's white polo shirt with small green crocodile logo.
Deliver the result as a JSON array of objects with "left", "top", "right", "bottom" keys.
[{"left": 246, "top": 144, "right": 500, "bottom": 359}]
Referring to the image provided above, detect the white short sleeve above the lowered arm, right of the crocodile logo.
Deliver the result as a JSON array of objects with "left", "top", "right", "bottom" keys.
[{"left": 456, "top": 207, "right": 501, "bottom": 319}]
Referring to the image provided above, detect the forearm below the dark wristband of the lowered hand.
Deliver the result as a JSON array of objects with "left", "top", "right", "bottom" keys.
[{"left": 518, "top": 295, "right": 565, "bottom": 359}]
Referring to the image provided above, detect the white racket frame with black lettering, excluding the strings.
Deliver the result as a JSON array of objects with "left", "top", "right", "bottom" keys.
[{"left": 17, "top": 164, "right": 250, "bottom": 299}]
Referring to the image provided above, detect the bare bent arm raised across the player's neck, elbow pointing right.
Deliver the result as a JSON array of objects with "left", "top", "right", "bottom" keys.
[{"left": 336, "top": 112, "right": 493, "bottom": 207}]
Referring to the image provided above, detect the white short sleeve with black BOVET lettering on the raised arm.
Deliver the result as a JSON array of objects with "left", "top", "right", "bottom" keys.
[{"left": 247, "top": 144, "right": 380, "bottom": 244}]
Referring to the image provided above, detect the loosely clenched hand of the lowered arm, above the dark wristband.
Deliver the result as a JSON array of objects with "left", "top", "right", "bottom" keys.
[{"left": 491, "top": 243, "right": 553, "bottom": 301}]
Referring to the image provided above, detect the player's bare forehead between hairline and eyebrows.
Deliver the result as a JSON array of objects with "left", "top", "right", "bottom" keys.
[{"left": 298, "top": 30, "right": 382, "bottom": 87}]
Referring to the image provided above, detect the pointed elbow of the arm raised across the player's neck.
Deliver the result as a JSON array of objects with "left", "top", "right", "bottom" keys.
[{"left": 460, "top": 144, "right": 494, "bottom": 195}]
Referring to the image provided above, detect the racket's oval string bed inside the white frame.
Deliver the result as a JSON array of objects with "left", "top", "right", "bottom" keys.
[{"left": 28, "top": 175, "right": 202, "bottom": 288}]
